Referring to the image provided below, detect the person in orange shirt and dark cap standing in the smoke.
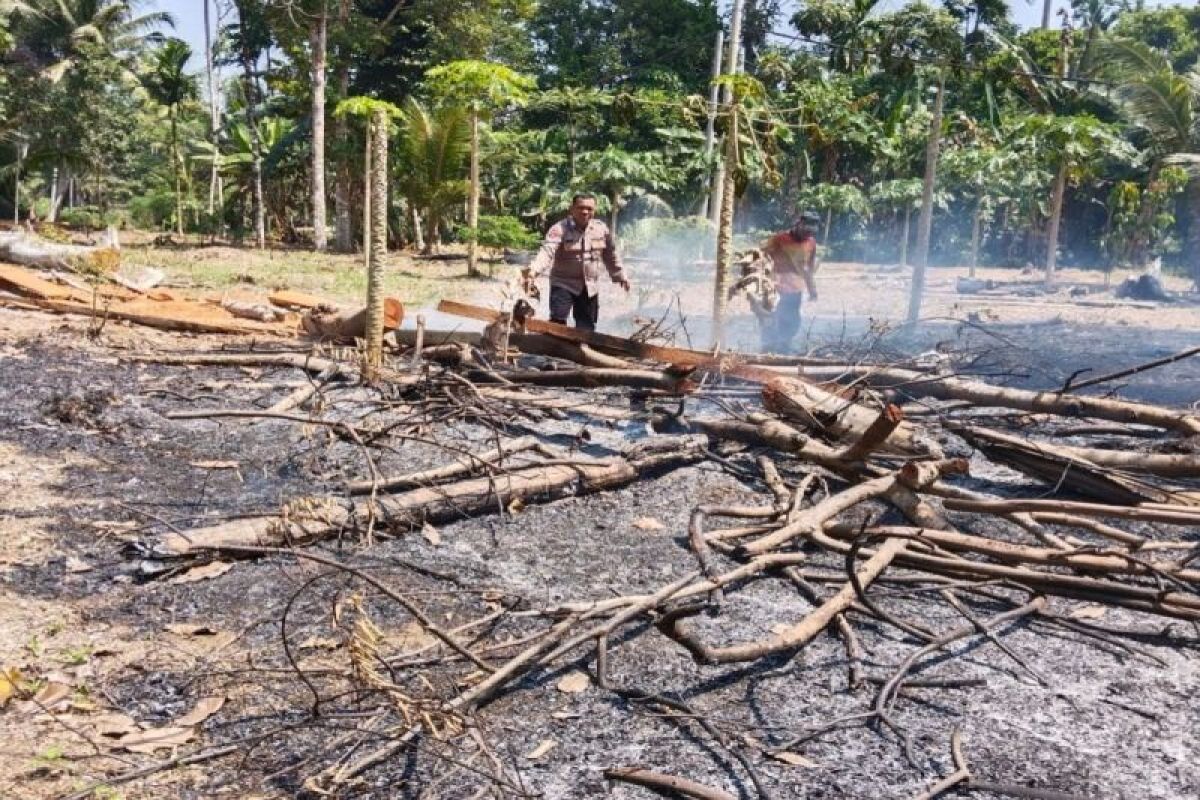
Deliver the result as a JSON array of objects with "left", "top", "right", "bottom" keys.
[{"left": 762, "top": 211, "right": 821, "bottom": 353}]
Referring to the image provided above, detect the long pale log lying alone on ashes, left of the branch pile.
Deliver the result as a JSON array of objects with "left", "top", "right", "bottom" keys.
[{"left": 140, "top": 437, "right": 707, "bottom": 559}]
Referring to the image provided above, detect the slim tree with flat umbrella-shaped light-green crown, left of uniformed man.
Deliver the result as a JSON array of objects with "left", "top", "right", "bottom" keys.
[{"left": 426, "top": 60, "right": 536, "bottom": 276}]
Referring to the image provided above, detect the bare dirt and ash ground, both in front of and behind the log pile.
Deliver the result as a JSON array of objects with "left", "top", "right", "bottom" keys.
[{"left": 0, "top": 247, "right": 1200, "bottom": 800}]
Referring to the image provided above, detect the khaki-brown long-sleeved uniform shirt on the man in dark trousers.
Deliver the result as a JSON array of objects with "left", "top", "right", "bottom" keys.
[{"left": 529, "top": 217, "right": 625, "bottom": 297}]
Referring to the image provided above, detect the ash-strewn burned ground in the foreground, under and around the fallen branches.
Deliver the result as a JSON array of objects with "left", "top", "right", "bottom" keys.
[{"left": 0, "top": 304, "right": 1200, "bottom": 799}]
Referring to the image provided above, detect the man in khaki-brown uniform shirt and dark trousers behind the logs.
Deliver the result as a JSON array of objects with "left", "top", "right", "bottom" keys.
[{"left": 522, "top": 194, "right": 629, "bottom": 331}]
